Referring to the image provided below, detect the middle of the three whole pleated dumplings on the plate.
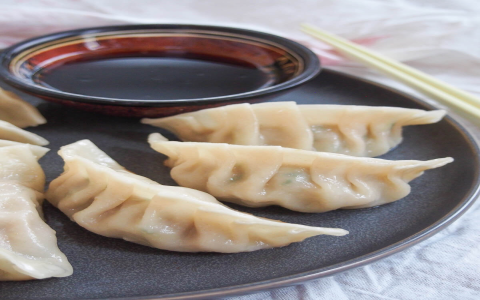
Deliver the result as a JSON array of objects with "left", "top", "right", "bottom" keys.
[{"left": 149, "top": 133, "right": 453, "bottom": 212}]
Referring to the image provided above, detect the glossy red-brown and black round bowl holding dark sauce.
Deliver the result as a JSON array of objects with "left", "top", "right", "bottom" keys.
[{"left": 0, "top": 25, "right": 320, "bottom": 117}]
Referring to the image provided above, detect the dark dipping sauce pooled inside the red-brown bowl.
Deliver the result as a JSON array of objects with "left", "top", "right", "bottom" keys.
[{"left": 33, "top": 57, "right": 276, "bottom": 100}]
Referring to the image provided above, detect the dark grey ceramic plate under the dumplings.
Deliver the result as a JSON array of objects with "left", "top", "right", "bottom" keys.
[{"left": 0, "top": 70, "right": 480, "bottom": 300}]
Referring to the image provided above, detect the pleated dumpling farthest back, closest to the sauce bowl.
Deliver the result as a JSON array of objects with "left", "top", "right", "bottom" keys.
[{"left": 142, "top": 102, "right": 445, "bottom": 157}]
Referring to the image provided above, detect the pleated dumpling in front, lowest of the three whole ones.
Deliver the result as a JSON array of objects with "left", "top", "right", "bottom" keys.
[{"left": 46, "top": 140, "right": 348, "bottom": 253}]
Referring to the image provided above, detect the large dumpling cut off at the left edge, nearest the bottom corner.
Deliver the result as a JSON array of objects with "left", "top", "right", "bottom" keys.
[{"left": 0, "top": 140, "right": 73, "bottom": 281}]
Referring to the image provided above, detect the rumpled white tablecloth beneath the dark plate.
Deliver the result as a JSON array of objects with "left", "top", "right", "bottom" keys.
[{"left": 0, "top": 0, "right": 480, "bottom": 300}]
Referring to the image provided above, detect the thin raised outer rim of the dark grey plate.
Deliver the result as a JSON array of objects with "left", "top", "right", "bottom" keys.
[{"left": 105, "top": 68, "right": 480, "bottom": 300}]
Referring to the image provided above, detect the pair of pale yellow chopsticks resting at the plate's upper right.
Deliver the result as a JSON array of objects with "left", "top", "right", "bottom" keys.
[{"left": 302, "top": 24, "right": 480, "bottom": 119}]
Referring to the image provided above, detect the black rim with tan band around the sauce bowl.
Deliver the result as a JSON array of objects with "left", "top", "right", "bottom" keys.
[{"left": 0, "top": 24, "right": 321, "bottom": 107}]
